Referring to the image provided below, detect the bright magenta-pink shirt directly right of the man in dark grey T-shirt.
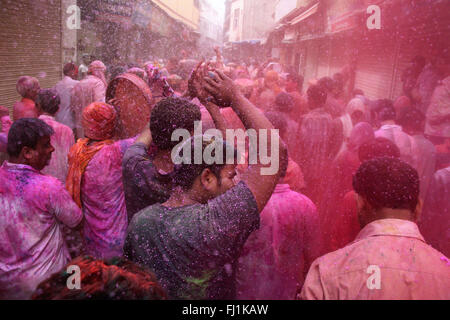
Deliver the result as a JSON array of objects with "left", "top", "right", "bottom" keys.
[{"left": 236, "top": 184, "right": 320, "bottom": 300}]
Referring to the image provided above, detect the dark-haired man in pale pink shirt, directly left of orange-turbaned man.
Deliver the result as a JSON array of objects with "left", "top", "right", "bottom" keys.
[{"left": 36, "top": 89, "right": 75, "bottom": 184}]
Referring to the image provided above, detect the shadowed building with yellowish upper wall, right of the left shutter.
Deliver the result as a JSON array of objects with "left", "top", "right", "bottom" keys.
[{"left": 78, "top": 0, "right": 200, "bottom": 65}]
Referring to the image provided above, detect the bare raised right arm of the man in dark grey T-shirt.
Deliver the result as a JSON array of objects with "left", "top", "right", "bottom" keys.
[{"left": 205, "top": 70, "right": 288, "bottom": 212}]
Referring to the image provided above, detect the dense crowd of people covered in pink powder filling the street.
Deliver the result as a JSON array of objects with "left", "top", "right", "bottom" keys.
[{"left": 0, "top": 49, "right": 450, "bottom": 300}]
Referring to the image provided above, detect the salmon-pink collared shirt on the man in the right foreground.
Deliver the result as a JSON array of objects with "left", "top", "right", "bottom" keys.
[{"left": 300, "top": 219, "right": 450, "bottom": 300}]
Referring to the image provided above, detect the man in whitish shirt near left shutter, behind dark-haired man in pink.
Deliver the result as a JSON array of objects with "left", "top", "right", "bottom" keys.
[{"left": 55, "top": 63, "right": 79, "bottom": 130}]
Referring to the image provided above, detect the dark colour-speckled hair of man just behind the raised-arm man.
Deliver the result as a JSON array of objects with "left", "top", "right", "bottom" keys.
[{"left": 150, "top": 98, "right": 202, "bottom": 150}]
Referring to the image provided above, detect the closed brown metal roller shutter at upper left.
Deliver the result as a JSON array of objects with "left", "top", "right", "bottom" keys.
[{"left": 0, "top": 0, "right": 62, "bottom": 109}]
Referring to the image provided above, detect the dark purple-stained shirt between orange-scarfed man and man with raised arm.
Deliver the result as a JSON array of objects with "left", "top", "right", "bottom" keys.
[{"left": 122, "top": 143, "right": 171, "bottom": 221}]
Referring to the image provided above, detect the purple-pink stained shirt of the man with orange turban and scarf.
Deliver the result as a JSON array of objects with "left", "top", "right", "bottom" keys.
[{"left": 81, "top": 138, "right": 135, "bottom": 259}]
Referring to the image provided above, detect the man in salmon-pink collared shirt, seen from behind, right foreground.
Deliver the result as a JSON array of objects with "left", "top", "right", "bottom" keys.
[{"left": 299, "top": 158, "right": 450, "bottom": 300}]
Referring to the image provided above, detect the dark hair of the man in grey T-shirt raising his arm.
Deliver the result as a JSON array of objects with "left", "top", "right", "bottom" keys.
[{"left": 172, "top": 136, "right": 238, "bottom": 190}]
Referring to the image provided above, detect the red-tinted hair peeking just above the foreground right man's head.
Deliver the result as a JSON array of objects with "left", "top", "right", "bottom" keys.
[{"left": 358, "top": 137, "right": 400, "bottom": 162}]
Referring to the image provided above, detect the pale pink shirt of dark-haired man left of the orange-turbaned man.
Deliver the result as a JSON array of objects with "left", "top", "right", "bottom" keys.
[{"left": 39, "top": 115, "right": 75, "bottom": 184}]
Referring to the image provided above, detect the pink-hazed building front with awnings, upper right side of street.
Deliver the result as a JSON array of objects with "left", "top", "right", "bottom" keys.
[{"left": 267, "top": 0, "right": 450, "bottom": 99}]
